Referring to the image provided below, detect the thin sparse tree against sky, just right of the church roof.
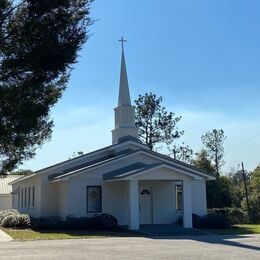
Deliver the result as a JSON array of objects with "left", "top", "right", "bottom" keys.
[{"left": 201, "top": 129, "right": 226, "bottom": 177}]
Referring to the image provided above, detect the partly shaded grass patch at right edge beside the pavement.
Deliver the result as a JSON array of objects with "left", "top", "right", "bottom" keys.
[{"left": 208, "top": 224, "right": 260, "bottom": 235}]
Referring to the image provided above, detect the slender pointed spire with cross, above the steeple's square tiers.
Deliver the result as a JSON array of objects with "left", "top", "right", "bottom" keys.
[{"left": 118, "top": 37, "right": 131, "bottom": 106}]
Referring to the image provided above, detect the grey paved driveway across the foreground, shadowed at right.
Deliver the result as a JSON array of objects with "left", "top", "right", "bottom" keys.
[{"left": 0, "top": 235, "right": 260, "bottom": 260}]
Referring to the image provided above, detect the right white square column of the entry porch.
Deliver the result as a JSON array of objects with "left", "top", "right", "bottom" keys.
[{"left": 182, "top": 180, "right": 192, "bottom": 228}]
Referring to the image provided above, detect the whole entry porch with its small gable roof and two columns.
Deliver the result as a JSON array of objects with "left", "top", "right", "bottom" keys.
[{"left": 104, "top": 165, "right": 200, "bottom": 230}]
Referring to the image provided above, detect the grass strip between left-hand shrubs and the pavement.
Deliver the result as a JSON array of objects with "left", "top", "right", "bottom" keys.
[{"left": 2, "top": 228, "right": 138, "bottom": 241}]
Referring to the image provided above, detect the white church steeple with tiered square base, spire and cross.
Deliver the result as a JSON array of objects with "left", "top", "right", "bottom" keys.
[{"left": 112, "top": 37, "right": 138, "bottom": 144}]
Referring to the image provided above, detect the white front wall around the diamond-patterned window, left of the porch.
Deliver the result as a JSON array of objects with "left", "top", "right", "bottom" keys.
[{"left": 60, "top": 178, "right": 127, "bottom": 225}]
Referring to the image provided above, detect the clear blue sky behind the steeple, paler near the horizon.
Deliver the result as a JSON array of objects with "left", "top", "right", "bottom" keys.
[{"left": 21, "top": 0, "right": 260, "bottom": 175}]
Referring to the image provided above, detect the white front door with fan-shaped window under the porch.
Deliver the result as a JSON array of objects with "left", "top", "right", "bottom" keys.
[{"left": 139, "top": 186, "right": 153, "bottom": 224}]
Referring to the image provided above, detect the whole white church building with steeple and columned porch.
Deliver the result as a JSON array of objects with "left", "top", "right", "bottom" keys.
[{"left": 11, "top": 42, "right": 215, "bottom": 230}]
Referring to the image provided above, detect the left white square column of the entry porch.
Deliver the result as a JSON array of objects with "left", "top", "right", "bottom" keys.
[{"left": 128, "top": 180, "right": 139, "bottom": 230}]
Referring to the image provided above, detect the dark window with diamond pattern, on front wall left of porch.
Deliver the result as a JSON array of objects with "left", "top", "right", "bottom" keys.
[{"left": 87, "top": 186, "right": 102, "bottom": 213}]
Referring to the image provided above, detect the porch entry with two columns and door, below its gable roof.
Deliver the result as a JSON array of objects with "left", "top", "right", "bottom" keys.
[{"left": 127, "top": 180, "right": 192, "bottom": 230}]
